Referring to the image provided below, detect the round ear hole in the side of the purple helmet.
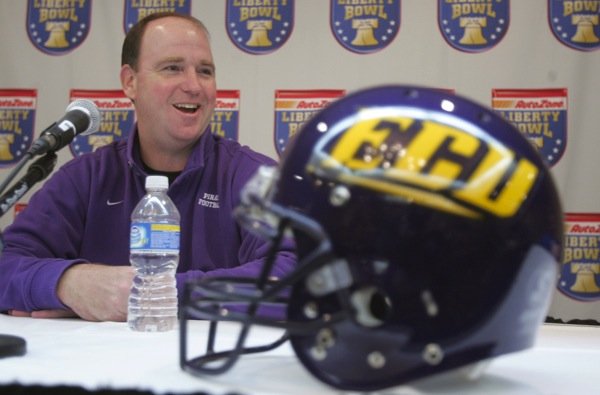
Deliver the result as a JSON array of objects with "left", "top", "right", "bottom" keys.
[{"left": 350, "top": 286, "right": 392, "bottom": 328}]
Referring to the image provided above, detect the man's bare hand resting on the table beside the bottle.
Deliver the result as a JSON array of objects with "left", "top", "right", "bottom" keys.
[{"left": 56, "top": 263, "right": 134, "bottom": 321}]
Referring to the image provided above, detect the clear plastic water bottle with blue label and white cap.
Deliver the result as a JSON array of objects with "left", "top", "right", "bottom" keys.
[{"left": 127, "top": 176, "right": 180, "bottom": 332}]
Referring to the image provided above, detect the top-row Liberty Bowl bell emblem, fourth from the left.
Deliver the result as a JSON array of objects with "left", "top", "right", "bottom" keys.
[{"left": 330, "top": 0, "right": 400, "bottom": 54}]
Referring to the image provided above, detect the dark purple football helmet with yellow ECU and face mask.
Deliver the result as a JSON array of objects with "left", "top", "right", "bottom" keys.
[{"left": 180, "top": 86, "right": 563, "bottom": 391}]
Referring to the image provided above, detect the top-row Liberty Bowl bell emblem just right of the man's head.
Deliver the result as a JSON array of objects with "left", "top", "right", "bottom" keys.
[{"left": 225, "top": 0, "right": 294, "bottom": 55}]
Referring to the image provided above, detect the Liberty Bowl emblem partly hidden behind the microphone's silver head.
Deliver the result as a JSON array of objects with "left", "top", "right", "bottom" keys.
[{"left": 69, "top": 89, "right": 135, "bottom": 157}]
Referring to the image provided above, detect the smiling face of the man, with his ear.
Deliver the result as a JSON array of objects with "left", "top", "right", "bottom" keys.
[{"left": 121, "top": 17, "right": 217, "bottom": 155}]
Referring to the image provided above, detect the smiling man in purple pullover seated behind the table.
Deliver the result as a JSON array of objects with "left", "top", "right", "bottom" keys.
[{"left": 0, "top": 13, "right": 295, "bottom": 321}]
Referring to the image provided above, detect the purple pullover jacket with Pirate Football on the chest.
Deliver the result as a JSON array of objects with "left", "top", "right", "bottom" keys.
[{"left": 0, "top": 131, "right": 296, "bottom": 311}]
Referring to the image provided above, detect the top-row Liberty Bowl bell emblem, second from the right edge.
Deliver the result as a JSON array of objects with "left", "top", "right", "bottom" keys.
[{"left": 438, "top": 0, "right": 510, "bottom": 52}]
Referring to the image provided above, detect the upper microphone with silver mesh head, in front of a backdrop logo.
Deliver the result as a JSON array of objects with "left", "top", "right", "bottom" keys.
[{"left": 27, "top": 99, "right": 100, "bottom": 156}]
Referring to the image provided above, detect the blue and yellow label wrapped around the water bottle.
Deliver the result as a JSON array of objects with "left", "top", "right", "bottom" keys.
[{"left": 129, "top": 222, "right": 180, "bottom": 254}]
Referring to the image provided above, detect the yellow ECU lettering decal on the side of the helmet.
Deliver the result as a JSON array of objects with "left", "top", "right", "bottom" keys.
[{"left": 307, "top": 116, "right": 539, "bottom": 218}]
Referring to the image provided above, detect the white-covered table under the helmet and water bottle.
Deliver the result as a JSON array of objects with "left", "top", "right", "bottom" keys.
[{"left": 0, "top": 315, "right": 600, "bottom": 395}]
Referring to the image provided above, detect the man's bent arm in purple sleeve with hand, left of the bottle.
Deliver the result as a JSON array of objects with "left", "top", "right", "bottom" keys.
[{"left": 0, "top": 155, "right": 133, "bottom": 321}]
